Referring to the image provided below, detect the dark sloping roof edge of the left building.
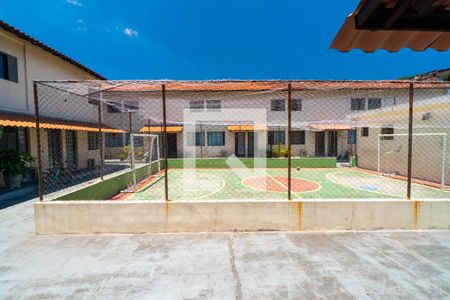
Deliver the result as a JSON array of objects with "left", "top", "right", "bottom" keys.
[{"left": 0, "top": 20, "right": 106, "bottom": 80}]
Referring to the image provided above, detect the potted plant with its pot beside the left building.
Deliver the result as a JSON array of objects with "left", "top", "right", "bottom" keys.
[{"left": 0, "top": 149, "right": 34, "bottom": 189}]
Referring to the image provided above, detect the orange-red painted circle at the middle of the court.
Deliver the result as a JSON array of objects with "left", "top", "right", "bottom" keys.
[{"left": 242, "top": 176, "right": 320, "bottom": 193}]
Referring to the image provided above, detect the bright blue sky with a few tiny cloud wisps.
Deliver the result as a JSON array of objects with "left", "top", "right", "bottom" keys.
[{"left": 0, "top": 0, "right": 450, "bottom": 79}]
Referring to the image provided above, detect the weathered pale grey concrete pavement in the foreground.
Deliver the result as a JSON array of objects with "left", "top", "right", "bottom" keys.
[{"left": 0, "top": 201, "right": 450, "bottom": 299}]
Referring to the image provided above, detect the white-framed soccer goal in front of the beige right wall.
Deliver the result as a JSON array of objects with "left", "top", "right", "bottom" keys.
[{"left": 377, "top": 132, "right": 447, "bottom": 190}]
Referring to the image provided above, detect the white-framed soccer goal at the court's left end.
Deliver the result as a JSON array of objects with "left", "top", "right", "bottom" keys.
[{"left": 129, "top": 133, "right": 161, "bottom": 192}]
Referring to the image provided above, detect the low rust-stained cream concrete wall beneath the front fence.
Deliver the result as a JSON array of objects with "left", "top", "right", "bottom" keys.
[{"left": 34, "top": 200, "right": 450, "bottom": 234}]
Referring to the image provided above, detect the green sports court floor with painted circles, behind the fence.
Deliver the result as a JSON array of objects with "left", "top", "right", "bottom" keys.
[{"left": 122, "top": 168, "right": 450, "bottom": 201}]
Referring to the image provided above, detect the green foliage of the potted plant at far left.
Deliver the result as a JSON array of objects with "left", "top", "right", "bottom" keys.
[{"left": 0, "top": 149, "right": 34, "bottom": 177}]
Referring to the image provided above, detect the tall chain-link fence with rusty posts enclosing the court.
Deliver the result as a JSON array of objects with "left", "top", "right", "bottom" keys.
[{"left": 32, "top": 81, "right": 450, "bottom": 201}]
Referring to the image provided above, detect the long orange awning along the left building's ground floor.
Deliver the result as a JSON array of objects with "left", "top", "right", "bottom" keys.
[{"left": 0, "top": 113, "right": 125, "bottom": 133}]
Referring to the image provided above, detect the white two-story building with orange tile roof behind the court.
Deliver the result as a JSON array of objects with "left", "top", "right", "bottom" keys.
[{"left": 89, "top": 81, "right": 447, "bottom": 166}]
